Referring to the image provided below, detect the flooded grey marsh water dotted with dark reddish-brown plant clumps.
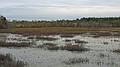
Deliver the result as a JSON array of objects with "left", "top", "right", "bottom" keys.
[{"left": 0, "top": 33, "right": 120, "bottom": 67}]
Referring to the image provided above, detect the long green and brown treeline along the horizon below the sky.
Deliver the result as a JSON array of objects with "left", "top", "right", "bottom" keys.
[{"left": 0, "top": 17, "right": 120, "bottom": 28}]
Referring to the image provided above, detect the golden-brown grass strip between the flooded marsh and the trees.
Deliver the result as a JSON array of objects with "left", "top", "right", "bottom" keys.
[{"left": 0, "top": 27, "right": 120, "bottom": 34}]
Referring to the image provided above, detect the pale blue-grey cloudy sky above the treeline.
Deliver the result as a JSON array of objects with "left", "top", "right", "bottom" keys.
[{"left": 0, "top": 0, "right": 120, "bottom": 20}]
